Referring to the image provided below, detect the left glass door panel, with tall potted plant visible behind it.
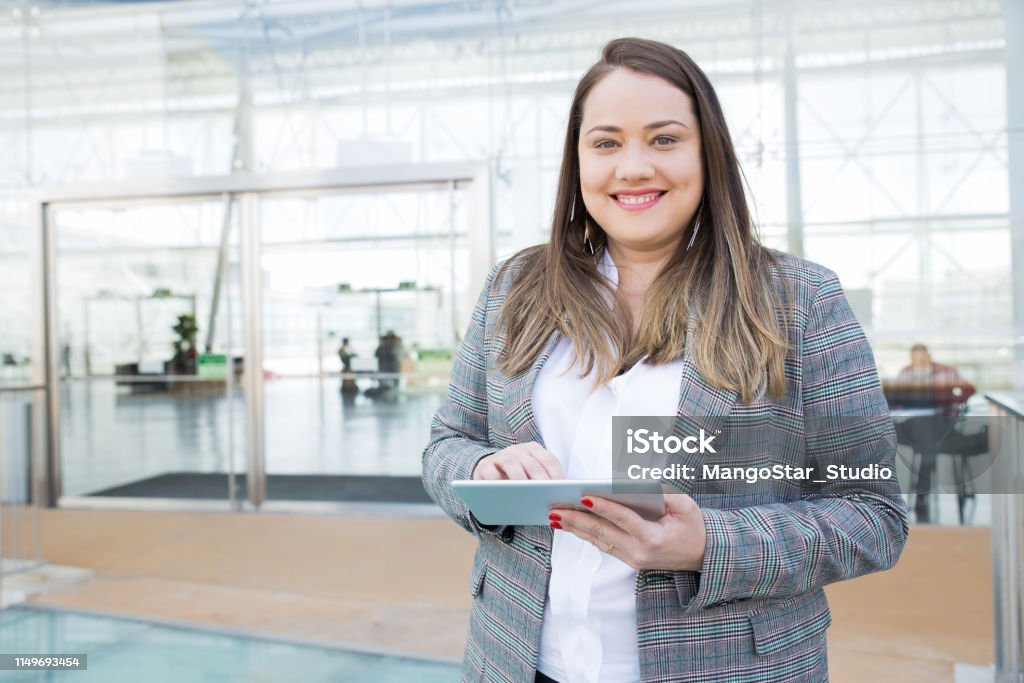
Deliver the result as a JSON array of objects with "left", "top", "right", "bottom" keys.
[{"left": 49, "top": 195, "right": 246, "bottom": 502}]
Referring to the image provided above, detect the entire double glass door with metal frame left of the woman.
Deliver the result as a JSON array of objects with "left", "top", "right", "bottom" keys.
[{"left": 38, "top": 164, "right": 493, "bottom": 509}]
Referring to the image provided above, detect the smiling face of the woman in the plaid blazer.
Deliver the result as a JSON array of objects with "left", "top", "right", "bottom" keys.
[{"left": 580, "top": 68, "right": 703, "bottom": 252}]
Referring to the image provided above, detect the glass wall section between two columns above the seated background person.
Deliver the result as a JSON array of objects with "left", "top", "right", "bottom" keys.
[{"left": 799, "top": 61, "right": 1013, "bottom": 378}]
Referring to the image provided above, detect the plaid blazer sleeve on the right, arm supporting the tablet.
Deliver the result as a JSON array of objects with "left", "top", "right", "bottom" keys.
[{"left": 685, "top": 273, "right": 908, "bottom": 613}]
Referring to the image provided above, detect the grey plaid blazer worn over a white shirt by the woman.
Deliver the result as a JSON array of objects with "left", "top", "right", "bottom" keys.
[{"left": 423, "top": 254, "right": 907, "bottom": 683}]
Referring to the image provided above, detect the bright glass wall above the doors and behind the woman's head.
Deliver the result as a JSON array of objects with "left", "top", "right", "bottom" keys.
[{"left": 0, "top": 0, "right": 1013, "bottom": 388}]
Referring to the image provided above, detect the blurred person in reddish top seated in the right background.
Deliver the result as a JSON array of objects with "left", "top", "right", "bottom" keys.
[{"left": 886, "top": 343, "right": 975, "bottom": 522}]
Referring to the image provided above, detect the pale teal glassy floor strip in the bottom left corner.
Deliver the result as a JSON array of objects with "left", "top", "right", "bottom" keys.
[{"left": 0, "top": 607, "right": 459, "bottom": 683}]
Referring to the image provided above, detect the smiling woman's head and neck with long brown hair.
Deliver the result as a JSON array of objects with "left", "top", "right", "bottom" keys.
[{"left": 491, "top": 39, "right": 790, "bottom": 402}]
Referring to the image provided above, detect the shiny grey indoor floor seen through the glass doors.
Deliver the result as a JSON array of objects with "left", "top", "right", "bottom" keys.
[{"left": 60, "top": 378, "right": 442, "bottom": 498}]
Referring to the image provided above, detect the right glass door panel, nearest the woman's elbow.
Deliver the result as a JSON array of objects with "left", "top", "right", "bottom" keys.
[{"left": 258, "top": 183, "right": 469, "bottom": 504}]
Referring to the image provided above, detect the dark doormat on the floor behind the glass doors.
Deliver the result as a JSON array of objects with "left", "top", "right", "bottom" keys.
[{"left": 82, "top": 472, "right": 433, "bottom": 504}]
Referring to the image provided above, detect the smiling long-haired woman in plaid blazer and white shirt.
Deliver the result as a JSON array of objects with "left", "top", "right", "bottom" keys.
[{"left": 423, "top": 39, "right": 907, "bottom": 683}]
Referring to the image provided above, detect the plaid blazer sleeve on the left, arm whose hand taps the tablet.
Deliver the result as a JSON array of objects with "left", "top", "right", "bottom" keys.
[{"left": 423, "top": 264, "right": 504, "bottom": 535}]
